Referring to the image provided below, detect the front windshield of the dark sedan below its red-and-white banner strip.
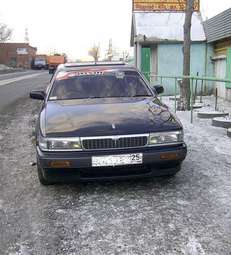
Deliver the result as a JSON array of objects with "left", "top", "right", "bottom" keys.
[{"left": 49, "top": 72, "right": 152, "bottom": 100}]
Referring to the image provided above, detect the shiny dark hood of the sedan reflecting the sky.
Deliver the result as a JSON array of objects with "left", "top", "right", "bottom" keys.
[{"left": 42, "top": 97, "right": 182, "bottom": 137}]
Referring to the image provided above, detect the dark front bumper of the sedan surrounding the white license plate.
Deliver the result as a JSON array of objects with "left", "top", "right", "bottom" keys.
[{"left": 37, "top": 143, "right": 187, "bottom": 182}]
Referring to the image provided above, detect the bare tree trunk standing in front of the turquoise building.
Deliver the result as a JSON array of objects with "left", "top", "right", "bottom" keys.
[{"left": 180, "top": 0, "right": 194, "bottom": 111}]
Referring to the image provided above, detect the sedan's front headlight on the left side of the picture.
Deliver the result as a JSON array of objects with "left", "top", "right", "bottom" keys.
[{"left": 39, "top": 136, "right": 82, "bottom": 151}]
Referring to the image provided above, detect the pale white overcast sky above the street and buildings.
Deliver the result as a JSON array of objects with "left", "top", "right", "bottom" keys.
[{"left": 0, "top": 0, "right": 231, "bottom": 59}]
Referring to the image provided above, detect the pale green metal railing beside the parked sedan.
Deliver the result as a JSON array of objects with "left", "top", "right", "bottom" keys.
[{"left": 143, "top": 73, "right": 231, "bottom": 123}]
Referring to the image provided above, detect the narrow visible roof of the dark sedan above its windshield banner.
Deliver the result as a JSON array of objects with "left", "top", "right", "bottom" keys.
[{"left": 57, "top": 62, "right": 137, "bottom": 71}]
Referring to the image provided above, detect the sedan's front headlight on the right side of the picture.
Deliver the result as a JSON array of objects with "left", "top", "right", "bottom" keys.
[{"left": 148, "top": 130, "right": 184, "bottom": 145}]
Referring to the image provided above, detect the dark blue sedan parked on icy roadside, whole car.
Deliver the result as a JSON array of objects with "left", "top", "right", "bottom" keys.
[{"left": 30, "top": 63, "right": 187, "bottom": 185}]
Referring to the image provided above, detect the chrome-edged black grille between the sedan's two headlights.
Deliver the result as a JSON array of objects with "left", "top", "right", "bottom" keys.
[{"left": 82, "top": 135, "right": 148, "bottom": 150}]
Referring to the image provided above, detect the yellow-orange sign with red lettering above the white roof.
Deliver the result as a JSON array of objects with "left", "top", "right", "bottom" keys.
[{"left": 133, "top": 0, "right": 200, "bottom": 12}]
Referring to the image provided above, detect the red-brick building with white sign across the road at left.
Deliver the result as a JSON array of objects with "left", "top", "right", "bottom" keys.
[{"left": 0, "top": 43, "right": 37, "bottom": 68}]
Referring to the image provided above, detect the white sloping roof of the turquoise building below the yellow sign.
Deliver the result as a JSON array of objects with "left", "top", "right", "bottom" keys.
[{"left": 131, "top": 12, "right": 206, "bottom": 45}]
